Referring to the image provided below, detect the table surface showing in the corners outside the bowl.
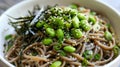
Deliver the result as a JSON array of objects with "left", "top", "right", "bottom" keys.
[{"left": 0, "top": 0, "right": 120, "bottom": 67}]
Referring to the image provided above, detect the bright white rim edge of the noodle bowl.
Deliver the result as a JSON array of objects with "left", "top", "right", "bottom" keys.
[{"left": 0, "top": 0, "right": 120, "bottom": 67}]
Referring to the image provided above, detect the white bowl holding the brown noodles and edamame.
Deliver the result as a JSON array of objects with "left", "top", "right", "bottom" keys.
[{"left": 0, "top": 0, "right": 120, "bottom": 67}]
